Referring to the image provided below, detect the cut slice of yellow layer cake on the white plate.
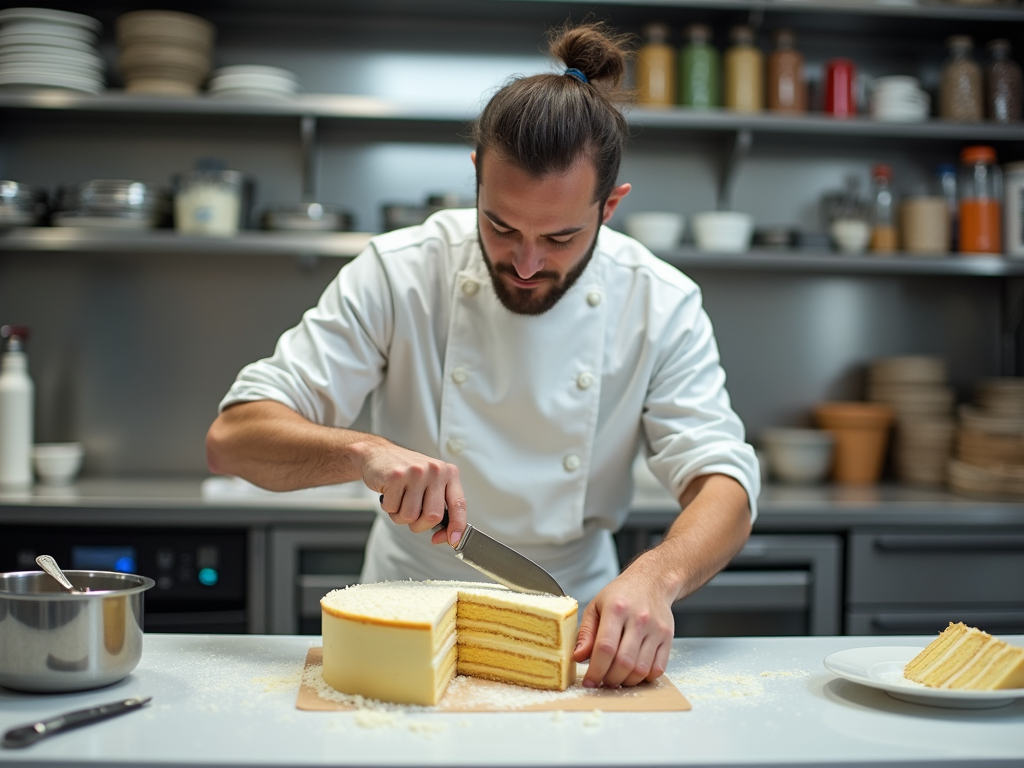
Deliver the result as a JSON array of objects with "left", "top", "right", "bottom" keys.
[{"left": 903, "top": 623, "right": 1024, "bottom": 690}]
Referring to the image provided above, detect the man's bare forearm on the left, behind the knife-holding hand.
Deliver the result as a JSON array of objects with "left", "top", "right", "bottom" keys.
[{"left": 206, "top": 400, "right": 387, "bottom": 490}]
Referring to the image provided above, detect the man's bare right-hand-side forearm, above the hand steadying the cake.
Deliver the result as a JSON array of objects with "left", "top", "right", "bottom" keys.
[{"left": 629, "top": 475, "right": 751, "bottom": 602}]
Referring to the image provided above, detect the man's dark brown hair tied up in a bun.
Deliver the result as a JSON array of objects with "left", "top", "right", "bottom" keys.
[{"left": 473, "top": 22, "right": 629, "bottom": 203}]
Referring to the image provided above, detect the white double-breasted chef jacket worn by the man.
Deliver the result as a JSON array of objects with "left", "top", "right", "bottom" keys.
[{"left": 220, "top": 210, "right": 760, "bottom": 604}]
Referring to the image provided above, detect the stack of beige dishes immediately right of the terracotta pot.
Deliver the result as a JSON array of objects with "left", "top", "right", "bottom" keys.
[{"left": 867, "top": 355, "right": 955, "bottom": 486}]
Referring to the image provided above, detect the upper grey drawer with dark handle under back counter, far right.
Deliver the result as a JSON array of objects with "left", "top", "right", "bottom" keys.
[{"left": 847, "top": 531, "right": 1024, "bottom": 605}]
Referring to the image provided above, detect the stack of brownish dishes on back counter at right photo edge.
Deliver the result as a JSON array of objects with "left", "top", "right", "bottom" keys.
[{"left": 949, "top": 378, "right": 1024, "bottom": 499}]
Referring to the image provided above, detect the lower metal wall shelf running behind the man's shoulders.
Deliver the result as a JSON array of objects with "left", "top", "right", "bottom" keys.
[{"left": 0, "top": 226, "right": 1024, "bottom": 278}]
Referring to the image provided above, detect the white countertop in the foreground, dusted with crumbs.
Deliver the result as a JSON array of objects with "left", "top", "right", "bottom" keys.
[{"left": 0, "top": 635, "right": 1024, "bottom": 768}]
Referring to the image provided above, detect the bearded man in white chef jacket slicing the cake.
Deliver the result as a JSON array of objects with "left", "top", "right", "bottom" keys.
[{"left": 207, "top": 25, "right": 759, "bottom": 687}]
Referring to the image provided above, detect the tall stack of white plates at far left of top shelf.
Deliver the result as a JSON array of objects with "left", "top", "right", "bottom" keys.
[{"left": 0, "top": 8, "right": 104, "bottom": 93}]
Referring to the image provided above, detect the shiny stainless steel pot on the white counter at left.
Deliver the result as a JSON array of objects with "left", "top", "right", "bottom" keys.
[{"left": 0, "top": 570, "right": 155, "bottom": 692}]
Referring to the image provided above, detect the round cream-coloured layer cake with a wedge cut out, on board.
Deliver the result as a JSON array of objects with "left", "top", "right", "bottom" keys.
[{"left": 321, "top": 582, "right": 578, "bottom": 705}]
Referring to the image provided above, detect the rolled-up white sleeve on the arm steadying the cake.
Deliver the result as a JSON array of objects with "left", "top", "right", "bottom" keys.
[{"left": 643, "top": 288, "right": 761, "bottom": 522}]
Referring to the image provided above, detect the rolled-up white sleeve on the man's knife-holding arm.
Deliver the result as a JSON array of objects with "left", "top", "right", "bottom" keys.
[{"left": 220, "top": 245, "right": 394, "bottom": 427}]
